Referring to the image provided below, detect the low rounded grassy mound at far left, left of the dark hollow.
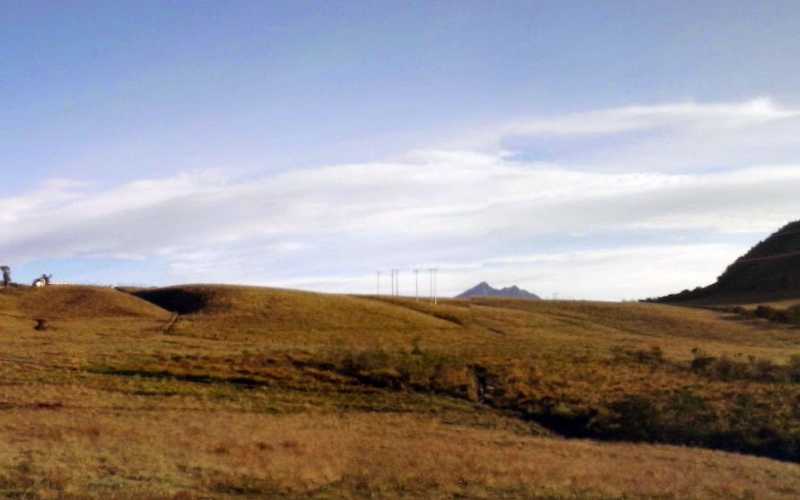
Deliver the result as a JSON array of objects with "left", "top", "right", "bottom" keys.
[{"left": 4, "top": 286, "right": 169, "bottom": 319}]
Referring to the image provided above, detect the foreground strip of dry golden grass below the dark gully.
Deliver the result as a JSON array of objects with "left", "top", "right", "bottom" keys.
[{"left": 0, "top": 410, "right": 800, "bottom": 499}]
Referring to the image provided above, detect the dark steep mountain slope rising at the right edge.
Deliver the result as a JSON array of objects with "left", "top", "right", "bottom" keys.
[{"left": 655, "top": 221, "right": 800, "bottom": 303}]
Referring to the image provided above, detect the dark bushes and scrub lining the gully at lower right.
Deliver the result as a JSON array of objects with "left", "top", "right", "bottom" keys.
[{"left": 326, "top": 346, "right": 800, "bottom": 461}]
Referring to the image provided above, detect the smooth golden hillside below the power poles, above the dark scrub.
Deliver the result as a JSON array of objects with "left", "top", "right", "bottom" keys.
[{"left": 131, "top": 285, "right": 800, "bottom": 362}]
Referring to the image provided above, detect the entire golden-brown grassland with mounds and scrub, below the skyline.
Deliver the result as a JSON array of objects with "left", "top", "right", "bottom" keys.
[{"left": 0, "top": 286, "right": 800, "bottom": 498}]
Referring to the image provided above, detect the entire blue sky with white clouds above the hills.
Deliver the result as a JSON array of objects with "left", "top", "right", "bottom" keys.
[{"left": 0, "top": 0, "right": 800, "bottom": 300}]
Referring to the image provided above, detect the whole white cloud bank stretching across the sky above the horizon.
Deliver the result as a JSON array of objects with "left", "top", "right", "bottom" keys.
[{"left": 0, "top": 99, "right": 800, "bottom": 299}]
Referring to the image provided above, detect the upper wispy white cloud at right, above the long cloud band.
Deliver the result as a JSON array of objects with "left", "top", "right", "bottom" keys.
[{"left": 460, "top": 97, "right": 800, "bottom": 172}]
